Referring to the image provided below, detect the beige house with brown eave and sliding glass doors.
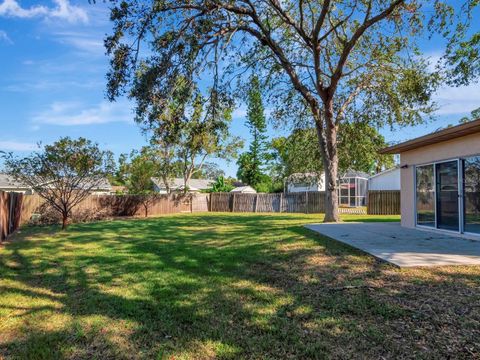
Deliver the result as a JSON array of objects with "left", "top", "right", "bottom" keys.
[{"left": 380, "top": 119, "right": 480, "bottom": 235}]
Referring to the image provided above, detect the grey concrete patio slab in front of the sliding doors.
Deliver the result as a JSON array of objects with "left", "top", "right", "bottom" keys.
[{"left": 306, "top": 223, "right": 480, "bottom": 267}]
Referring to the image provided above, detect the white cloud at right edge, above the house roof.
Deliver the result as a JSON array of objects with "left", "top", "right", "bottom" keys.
[{"left": 434, "top": 83, "right": 480, "bottom": 115}]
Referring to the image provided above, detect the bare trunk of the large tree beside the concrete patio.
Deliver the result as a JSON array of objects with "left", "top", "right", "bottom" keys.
[{"left": 316, "top": 99, "right": 340, "bottom": 222}]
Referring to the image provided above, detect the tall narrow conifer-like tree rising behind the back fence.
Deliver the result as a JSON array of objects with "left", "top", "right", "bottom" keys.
[{"left": 237, "top": 75, "right": 267, "bottom": 188}]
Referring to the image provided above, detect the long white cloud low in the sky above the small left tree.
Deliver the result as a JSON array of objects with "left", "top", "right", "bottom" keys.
[{"left": 33, "top": 101, "right": 133, "bottom": 126}]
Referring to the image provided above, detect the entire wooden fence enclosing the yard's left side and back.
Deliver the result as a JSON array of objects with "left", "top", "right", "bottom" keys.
[{"left": 0, "top": 191, "right": 400, "bottom": 241}]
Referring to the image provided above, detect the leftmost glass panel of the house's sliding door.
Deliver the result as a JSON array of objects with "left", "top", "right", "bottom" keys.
[{"left": 415, "top": 165, "right": 435, "bottom": 227}]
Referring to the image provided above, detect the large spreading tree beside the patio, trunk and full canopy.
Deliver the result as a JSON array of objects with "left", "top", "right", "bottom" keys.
[{"left": 106, "top": 0, "right": 472, "bottom": 221}]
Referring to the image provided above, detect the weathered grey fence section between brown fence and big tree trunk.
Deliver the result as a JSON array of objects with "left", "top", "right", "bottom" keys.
[{"left": 210, "top": 191, "right": 325, "bottom": 214}]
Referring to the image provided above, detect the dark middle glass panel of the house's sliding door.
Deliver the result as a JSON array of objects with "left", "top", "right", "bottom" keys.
[{"left": 435, "top": 160, "right": 459, "bottom": 231}]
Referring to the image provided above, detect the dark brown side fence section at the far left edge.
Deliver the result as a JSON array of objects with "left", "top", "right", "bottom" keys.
[{"left": 0, "top": 191, "right": 23, "bottom": 241}]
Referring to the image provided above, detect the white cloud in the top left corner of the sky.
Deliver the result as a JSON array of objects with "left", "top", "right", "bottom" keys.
[{"left": 0, "top": 0, "right": 88, "bottom": 23}]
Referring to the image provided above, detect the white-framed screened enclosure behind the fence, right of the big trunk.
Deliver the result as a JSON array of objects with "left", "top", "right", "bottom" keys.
[{"left": 338, "top": 171, "right": 368, "bottom": 207}]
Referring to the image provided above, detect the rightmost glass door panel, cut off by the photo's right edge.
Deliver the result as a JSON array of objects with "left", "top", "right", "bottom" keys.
[{"left": 463, "top": 156, "right": 480, "bottom": 234}]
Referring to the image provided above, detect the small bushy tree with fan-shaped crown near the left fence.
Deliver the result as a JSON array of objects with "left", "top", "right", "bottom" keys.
[{"left": 4, "top": 137, "right": 114, "bottom": 229}]
